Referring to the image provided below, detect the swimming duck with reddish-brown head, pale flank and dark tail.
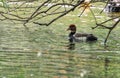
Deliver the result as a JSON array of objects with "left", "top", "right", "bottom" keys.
[{"left": 67, "top": 24, "right": 98, "bottom": 43}]
